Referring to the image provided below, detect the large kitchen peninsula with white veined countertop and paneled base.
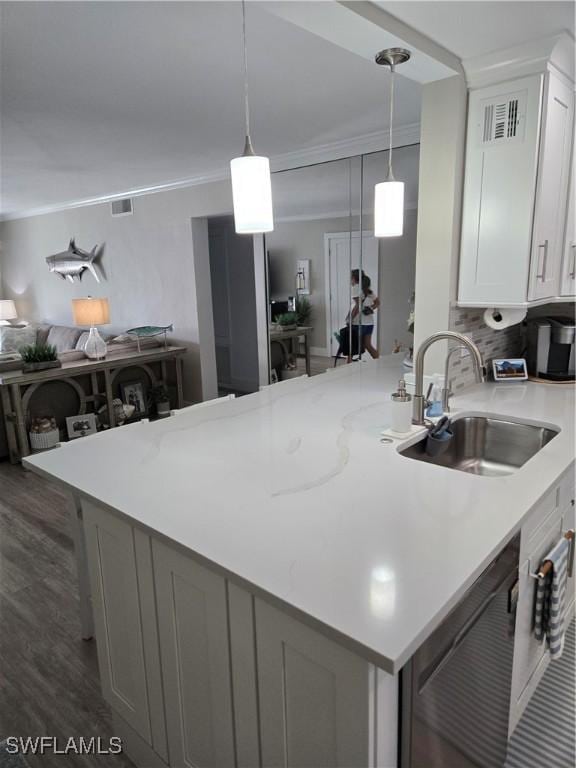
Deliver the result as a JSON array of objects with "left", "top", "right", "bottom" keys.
[{"left": 25, "top": 357, "right": 574, "bottom": 768}]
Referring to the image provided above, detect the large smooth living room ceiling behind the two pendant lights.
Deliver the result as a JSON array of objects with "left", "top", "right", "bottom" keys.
[{"left": 0, "top": 2, "right": 420, "bottom": 212}]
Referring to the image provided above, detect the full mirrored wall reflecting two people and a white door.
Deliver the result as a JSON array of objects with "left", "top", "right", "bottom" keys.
[{"left": 265, "top": 145, "right": 418, "bottom": 382}]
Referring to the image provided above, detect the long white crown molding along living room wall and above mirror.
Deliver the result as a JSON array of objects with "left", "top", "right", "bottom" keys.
[{"left": 0, "top": 123, "right": 420, "bottom": 221}]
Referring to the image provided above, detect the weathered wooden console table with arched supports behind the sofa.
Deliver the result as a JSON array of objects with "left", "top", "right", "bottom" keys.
[{"left": 0, "top": 347, "right": 186, "bottom": 464}]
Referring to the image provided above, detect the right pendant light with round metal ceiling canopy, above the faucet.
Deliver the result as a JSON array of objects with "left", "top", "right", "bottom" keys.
[{"left": 374, "top": 48, "right": 410, "bottom": 237}]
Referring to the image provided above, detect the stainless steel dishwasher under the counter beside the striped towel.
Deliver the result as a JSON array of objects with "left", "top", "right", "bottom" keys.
[{"left": 400, "top": 536, "right": 520, "bottom": 768}]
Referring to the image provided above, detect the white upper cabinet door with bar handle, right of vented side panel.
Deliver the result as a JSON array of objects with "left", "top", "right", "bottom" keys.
[{"left": 528, "top": 73, "right": 574, "bottom": 300}]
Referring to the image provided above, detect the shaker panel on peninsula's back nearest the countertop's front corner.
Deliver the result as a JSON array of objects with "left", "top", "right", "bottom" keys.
[{"left": 256, "top": 600, "right": 369, "bottom": 768}]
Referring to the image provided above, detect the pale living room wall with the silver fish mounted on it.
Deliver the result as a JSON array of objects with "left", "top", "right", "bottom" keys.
[{"left": 0, "top": 181, "right": 232, "bottom": 401}]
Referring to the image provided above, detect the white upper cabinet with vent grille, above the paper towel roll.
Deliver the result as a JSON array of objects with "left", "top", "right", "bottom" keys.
[{"left": 458, "top": 70, "right": 574, "bottom": 307}]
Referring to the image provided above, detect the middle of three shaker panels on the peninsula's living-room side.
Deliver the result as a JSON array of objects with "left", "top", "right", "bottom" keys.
[{"left": 152, "top": 540, "right": 234, "bottom": 768}]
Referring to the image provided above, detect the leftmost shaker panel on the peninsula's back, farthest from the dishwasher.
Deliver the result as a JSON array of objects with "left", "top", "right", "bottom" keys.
[{"left": 82, "top": 502, "right": 152, "bottom": 744}]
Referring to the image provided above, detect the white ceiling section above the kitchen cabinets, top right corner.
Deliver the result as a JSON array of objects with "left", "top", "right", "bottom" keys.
[{"left": 375, "top": 0, "right": 575, "bottom": 59}]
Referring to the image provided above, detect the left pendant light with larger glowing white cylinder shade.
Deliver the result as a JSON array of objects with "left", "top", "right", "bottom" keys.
[{"left": 230, "top": 0, "right": 274, "bottom": 235}]
